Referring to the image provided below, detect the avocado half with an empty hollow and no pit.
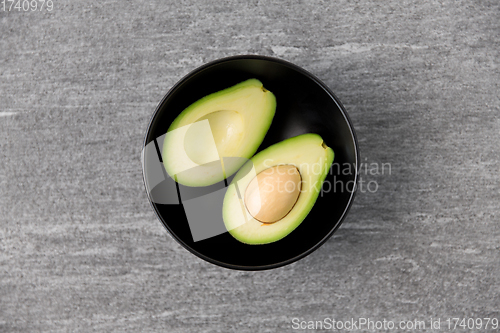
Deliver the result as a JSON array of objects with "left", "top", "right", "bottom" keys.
[{"left": 162, "top": 79, "right": 276, "bottom": 187}]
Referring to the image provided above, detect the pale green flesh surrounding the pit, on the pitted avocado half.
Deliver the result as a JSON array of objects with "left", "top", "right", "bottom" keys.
[{"left": 222, "top": 134, "right": 334, "bottom": 244}]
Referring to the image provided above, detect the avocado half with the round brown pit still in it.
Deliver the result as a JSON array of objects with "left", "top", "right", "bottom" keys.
[{"left": 222, "top": 134, "right": 334, "bottom": 244}]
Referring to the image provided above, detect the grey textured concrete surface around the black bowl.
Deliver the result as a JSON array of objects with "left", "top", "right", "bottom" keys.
[{"left": 0, "top": 0, "right": 500, "bottom": 332}]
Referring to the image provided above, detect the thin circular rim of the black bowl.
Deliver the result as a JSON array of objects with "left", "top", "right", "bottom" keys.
[{"left": 141, "top": 54, "right": 360, "bottom": 271}]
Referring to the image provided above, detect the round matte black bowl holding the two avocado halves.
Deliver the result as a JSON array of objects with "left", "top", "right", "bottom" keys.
[{"left": 143, "top": 56, "right": 359, "bottom": 270}]
